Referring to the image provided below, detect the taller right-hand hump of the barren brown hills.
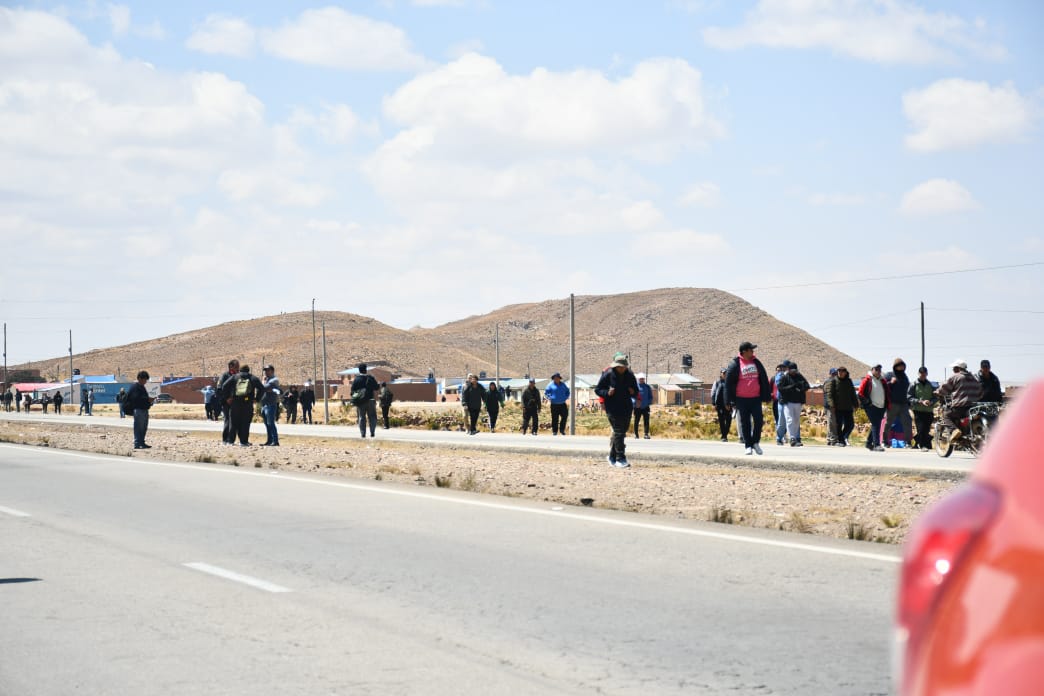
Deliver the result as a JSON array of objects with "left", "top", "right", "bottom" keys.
[{"left": 412, "top": 288, "right": 865, "bottom": 382}]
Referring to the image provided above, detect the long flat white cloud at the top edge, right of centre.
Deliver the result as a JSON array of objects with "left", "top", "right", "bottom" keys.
[{"left": 704, "top": 0, "right": 1007, "bottom": 65}]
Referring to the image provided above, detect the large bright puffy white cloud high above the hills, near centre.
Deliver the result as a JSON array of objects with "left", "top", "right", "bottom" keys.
[{"left": 384, "top": 53, "right": 723, "bottom": 158}]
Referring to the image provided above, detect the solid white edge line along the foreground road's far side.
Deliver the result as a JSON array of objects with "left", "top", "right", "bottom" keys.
[{"left": 0, "top": 445, "right": 902, "bottom": 563}]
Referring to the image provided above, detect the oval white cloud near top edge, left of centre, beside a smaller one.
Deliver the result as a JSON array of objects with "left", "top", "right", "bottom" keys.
[{"left": 260, "top": 7, "right": 426, "bottom": 71}]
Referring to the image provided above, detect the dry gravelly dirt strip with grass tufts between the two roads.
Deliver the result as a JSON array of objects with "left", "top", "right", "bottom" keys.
[{"left": 0, "top": 413, "right": 964, "bottom": 544}]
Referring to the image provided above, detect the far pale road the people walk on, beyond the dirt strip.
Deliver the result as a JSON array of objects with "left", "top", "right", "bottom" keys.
[{"left": 0, "top": 412, "right": 975, "bottom": 473}]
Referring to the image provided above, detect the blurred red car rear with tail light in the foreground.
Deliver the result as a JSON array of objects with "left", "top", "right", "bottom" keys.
[{"left": 896, "top": 380, "right": 1044, "bottom": 696}]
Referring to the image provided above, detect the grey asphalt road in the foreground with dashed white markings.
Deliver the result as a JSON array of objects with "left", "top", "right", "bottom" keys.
[{"left": 0, "top": 444, "right": 898, "bottom": 696}]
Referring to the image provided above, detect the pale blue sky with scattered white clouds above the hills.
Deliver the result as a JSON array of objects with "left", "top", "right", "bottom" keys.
[{"left": 0, "top": 0, "right": 1044, "bottom": 381}]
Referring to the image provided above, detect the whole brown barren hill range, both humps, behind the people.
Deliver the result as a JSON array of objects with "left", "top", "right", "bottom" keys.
[{"left": 18, "top": 288, "right": 864, "bottom": 383}]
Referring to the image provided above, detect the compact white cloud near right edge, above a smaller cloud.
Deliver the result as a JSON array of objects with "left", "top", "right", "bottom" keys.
[{"left": 903, "top": 79, "right": 1034, "bottom": 152}]
